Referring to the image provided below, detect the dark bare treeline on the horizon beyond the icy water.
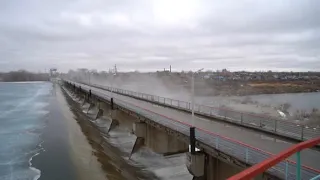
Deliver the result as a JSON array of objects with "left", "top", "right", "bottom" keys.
[{"left": 0, "top": 70, "right": 49, "bottom": 82}]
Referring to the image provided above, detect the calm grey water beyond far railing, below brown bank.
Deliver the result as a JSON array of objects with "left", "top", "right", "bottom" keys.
[{"left": 195, "top": 92, "right": 320, "bottom": 117}]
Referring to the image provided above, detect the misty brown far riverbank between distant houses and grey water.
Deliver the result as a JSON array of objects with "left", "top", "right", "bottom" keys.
[{"left": 86, "top": 73, "right": 320, "bottom": 96}]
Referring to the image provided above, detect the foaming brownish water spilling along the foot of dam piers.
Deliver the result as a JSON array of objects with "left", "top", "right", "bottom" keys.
[{"left": 66, "top": 86, "right": 192, "bottom": 180}]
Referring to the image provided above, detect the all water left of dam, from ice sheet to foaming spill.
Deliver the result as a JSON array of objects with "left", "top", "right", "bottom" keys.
[{"left": 0, "top": 82, "right": 192, "bottom": 180}]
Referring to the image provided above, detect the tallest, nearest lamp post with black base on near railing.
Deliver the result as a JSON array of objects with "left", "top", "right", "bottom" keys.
[{"left": 190, "top": 68, "right": 203, "bottom": 154}]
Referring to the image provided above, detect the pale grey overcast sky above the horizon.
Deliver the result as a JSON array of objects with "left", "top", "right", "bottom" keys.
[{"left": 0, "top": 0, "right": 320, "bottom": 71}]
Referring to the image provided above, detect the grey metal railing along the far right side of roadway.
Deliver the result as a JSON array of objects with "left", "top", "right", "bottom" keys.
[{"left": 86, "top": 84, "right": 320, "bottom": 141}]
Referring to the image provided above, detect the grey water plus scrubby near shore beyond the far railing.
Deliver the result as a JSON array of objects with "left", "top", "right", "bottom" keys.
[{"left": 195, "top": 92, "right": 320, "bottom": 127}]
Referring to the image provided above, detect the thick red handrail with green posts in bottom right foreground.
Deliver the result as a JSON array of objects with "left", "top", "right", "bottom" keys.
[{"left": 228, "top": 137, "right": 320, "bottom": 180}]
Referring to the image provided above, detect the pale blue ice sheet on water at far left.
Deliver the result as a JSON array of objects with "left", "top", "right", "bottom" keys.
[{"left": 0, "top": 83, "right": 51, "bottom": 180}]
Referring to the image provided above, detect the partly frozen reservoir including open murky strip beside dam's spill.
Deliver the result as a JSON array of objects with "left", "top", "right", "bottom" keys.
[{"left": 0, "top": 82, "right": 118, "bottom": 180}]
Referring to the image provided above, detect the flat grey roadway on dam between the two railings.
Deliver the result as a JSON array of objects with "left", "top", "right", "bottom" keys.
[{"left": 68, "top": 82, "right": 320, "bottom": 179}]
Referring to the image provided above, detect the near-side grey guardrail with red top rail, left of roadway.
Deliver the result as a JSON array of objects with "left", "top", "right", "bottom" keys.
[{"left": 64, "top": 82, "right": 320, "bottom": 180}]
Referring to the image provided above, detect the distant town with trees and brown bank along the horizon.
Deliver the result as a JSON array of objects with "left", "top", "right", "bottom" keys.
[{"left": 67, "top": 66, "right": 320, "bottom": 96}]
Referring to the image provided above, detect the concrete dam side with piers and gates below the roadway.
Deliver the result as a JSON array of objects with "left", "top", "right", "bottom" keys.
[{"left": 63, "top": 81, "right": 320, "bottom": 180}]
